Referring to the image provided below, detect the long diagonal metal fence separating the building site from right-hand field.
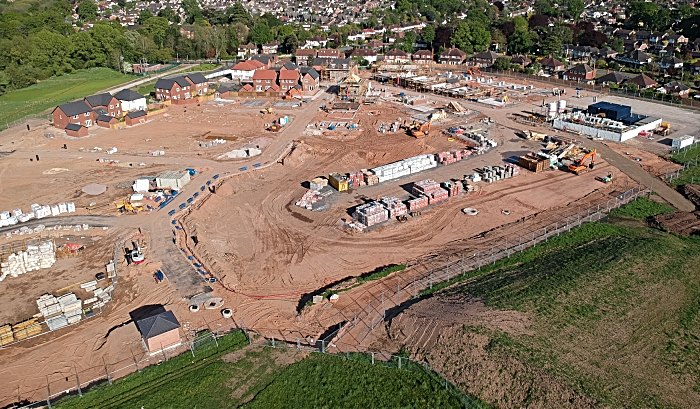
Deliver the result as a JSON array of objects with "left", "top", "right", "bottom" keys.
[{"left": 330, "top": 186, "right": 652, "bottom": 345}]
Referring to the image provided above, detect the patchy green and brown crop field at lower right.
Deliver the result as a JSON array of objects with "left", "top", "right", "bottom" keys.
[{"left": 422, "top": 202, "right": 700, "bottom": 408}]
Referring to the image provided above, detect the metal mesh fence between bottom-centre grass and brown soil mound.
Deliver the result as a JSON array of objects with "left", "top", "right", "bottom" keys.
[{"left": 245, "top": 330, "right": 481, "bottom": 409}]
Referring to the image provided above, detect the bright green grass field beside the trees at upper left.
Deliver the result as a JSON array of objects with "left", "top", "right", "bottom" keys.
[{"left": 0, "top": 68, "right": 135, "bottom": 125}]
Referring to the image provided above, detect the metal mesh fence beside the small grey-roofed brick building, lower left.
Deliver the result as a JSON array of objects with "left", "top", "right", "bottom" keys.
[{"left": 5, "top": 320, "right": 240, "bottom": 409}]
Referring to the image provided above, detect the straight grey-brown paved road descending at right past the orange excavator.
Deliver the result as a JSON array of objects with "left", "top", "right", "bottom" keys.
[{"left": 586, "top": 141, "right": 695, "bottom": 212}]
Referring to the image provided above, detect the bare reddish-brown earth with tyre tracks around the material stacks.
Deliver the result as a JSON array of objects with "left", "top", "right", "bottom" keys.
[{"left": 0, "top": 75, "right": 698, "bottom": 405}]
